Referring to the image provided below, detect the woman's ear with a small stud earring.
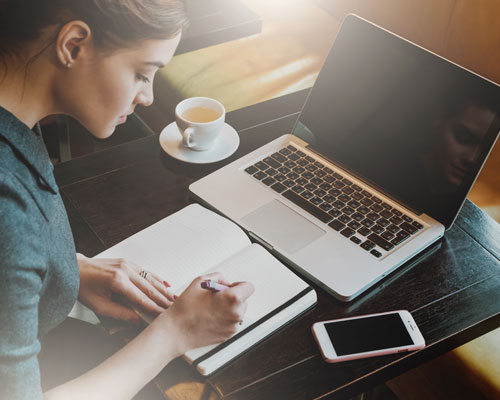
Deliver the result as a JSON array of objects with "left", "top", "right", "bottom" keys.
[{"left": 56, "top": 21, "right": 92, "bottom": 68}]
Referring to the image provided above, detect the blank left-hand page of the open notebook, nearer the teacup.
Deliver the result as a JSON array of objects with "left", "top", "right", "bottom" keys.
[{"left": 95, "top": 204, "right": 250, "bottom": 292}]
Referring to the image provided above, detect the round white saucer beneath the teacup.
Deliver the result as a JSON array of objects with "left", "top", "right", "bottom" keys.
[{"left": 160, "top": 122, "right": 240, "bottom": 164}]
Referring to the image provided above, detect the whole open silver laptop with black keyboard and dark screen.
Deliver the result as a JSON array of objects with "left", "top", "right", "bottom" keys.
[{"left": 190, "top": 15, "right": 500, "bottom": 301}]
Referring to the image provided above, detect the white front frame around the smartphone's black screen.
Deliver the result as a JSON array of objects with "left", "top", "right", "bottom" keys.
[{"left": 313, "top": 310, "right": 425, "bottom": 362}]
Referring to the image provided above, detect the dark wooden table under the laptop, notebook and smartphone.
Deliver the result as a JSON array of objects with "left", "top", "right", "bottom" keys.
[{"left": 55, "top": 91, "right": 500, "bottom": 400}]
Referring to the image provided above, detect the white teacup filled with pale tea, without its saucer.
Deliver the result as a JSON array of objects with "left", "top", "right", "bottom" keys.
[{"left": 175, "top": 97, "right": 226, "bottom": 151}]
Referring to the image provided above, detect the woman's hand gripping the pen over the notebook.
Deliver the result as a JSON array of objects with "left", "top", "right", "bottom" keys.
[{"left": 154, "top": 273, "right": 254, "bottom": 355}]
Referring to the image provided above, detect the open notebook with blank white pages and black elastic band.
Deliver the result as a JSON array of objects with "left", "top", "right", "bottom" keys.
[{"left": 96, "top": 204, "right": 317, "bottom": 375}]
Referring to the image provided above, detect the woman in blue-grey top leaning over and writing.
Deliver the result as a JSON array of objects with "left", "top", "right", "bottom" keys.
[{"left": 0, "top": 0, "right": 253, "bottom": 399}]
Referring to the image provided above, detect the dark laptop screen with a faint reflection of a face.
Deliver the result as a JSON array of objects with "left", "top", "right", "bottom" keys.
[{"left": 294, "top": 15, "right": 500, "bottom": 228}]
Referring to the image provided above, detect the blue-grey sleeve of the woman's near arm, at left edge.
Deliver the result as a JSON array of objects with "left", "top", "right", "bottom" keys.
[{"left": 0, "top": 171, "right": 45, "bottom": 400}]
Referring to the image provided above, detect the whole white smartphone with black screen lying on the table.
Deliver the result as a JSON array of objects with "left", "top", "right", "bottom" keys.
[{"left": 312, "top": 310, "right": 425, "bottom": 363}]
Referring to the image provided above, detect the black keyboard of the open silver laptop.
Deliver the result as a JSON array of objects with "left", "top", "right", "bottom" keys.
[{"left": 245, "top": 145, "right": 424, "bottom": 258}]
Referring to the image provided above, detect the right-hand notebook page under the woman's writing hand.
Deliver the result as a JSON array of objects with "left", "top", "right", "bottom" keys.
[{"left": 185, "top": 244, "right": 309, "bottom": 361}]
